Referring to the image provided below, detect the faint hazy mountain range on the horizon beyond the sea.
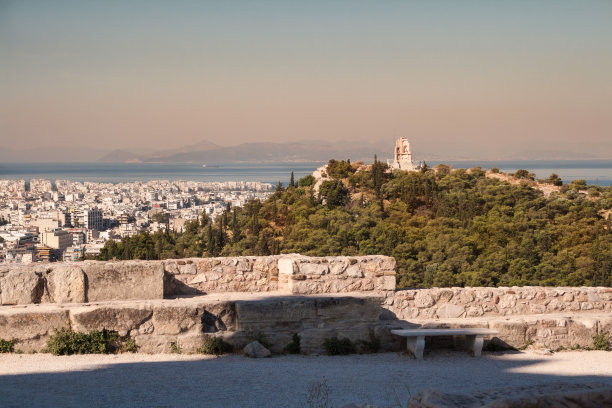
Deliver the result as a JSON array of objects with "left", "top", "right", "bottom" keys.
[{"left": 0, "top": 140, "right": 612, "bottom": 164}]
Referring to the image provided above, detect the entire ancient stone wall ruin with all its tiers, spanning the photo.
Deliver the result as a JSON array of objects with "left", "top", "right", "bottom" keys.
[{"left": 0, "top": 255, "right": 612, "bottom": 353}]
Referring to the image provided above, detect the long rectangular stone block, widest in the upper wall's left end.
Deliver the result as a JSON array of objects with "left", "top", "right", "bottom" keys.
[{"left": 83, "top": 261, "right": 164, "bottom": 302}]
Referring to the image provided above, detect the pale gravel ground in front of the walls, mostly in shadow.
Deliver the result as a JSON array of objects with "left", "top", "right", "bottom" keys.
[{"left": 0, "top": 350, "right": 612, "bottom": 407}]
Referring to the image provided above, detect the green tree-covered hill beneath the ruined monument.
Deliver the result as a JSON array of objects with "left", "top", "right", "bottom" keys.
[{"left": 101, "top": 160, "right": 612, "bottom": 288}]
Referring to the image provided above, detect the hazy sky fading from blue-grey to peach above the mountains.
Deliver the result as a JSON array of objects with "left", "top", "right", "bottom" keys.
[{"left": 0, "top": 0, "right": 612, "bottom": 158}]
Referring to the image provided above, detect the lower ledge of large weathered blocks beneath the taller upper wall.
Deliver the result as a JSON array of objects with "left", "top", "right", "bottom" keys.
[{"left": 0, "top": 295, "right": 392, "bottom": 354}]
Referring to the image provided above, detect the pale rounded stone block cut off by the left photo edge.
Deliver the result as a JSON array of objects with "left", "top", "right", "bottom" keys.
[{"left": 0, "top": 269, "right": 44, "bottom": 305}]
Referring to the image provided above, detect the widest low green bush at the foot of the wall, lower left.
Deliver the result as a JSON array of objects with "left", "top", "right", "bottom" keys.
[{"left": 47, "top": 329, "right": 122, "bottom": 356}]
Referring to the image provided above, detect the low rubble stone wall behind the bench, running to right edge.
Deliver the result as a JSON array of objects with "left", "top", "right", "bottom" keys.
[{"left": 386, "top": 286, "right": 612, "bottom": 321}]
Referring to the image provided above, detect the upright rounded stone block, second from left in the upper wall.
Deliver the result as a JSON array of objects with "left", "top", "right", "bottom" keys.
[{"left": 47, "top": 265, "right": 87, "bottom": 303}]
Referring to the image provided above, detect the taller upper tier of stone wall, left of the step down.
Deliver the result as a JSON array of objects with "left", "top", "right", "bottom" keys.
[{"left": 0, "top": 255, "right": 395, "bottom": 305}]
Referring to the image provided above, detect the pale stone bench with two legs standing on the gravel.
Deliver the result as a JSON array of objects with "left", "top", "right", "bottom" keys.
[{"left": 391, "top": 328, "right": 497, "bottom": 360}]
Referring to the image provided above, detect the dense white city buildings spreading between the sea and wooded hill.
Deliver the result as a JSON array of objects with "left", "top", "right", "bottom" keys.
[{"left": 0, "top": 179, "right": 274, "bottom": 263}]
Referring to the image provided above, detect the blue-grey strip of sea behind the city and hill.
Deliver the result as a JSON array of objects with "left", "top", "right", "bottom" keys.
[{"left": 0, "top": 160, "right": 612, "bottom": 187}]
